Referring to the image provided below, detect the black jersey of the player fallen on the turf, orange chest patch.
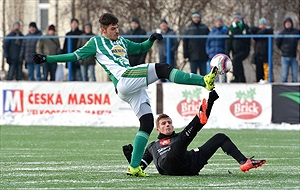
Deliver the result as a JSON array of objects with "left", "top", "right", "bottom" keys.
[{"left": 142, "top": 132, "right": 199, "bottom": 175}]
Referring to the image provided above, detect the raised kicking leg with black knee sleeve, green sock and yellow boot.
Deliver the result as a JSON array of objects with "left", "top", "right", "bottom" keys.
[{"left": 154, "top": 63, "right": 218, "bottom": 91}]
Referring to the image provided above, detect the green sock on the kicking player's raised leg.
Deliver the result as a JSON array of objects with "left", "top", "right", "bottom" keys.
[{"left": 169, "top": 69, "right": 205, "bottom": 87}]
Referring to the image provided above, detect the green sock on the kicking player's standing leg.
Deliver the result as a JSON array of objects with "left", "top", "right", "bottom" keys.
[{"left": 130, "top": 131, "right": 150, "bottom": 168}]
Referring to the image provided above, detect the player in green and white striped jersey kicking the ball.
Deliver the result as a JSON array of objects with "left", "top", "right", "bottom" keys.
[{"left": 33, "top": 13, "right": 218, "bottom": 177}]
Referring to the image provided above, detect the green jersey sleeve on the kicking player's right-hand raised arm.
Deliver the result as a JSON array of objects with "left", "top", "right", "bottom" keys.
[{"left": 125, "top": 39, "right": 154, "bottom": 54}]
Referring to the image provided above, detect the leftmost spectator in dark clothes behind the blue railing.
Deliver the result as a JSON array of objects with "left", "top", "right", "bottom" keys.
[{"left": 3, "top": 21, "right": 23, "bottom": 81}]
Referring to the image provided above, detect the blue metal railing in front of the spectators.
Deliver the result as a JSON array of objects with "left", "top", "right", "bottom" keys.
[{"left": 0, "top": 34, "right": 300, "bottom": 82}]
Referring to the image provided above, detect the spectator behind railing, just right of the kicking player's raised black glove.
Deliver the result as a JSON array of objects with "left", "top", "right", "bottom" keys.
[{"left": 157, "top": 19, "right": 179, "bottom": 82}]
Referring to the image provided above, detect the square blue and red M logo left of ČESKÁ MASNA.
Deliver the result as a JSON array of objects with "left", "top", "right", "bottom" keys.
[{"left": 2, "top": 90, "right": 24, "bottom": 113}]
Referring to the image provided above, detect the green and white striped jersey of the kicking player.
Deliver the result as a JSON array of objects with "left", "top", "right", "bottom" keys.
[{"left": 74, "top": 36, "right": 153, "bottom": 86}]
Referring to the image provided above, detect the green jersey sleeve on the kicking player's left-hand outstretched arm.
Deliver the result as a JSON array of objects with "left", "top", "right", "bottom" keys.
[{"left": 74, "top": 37, "right": 96, "bottom": 60}]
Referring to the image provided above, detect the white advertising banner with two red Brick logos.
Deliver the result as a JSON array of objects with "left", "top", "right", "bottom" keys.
[{"left": 163, "top": 83, "right": 272, "bottom": 128}]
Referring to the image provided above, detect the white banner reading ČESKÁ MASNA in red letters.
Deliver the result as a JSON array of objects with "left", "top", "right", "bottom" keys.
[{"left": 0, "top": 82, "right": 156, "bottom": 126}]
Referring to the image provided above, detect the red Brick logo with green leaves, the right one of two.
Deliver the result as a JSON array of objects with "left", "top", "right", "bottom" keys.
[{"left": 230, "top": 88, "right": 262, "bottom": 119}]
